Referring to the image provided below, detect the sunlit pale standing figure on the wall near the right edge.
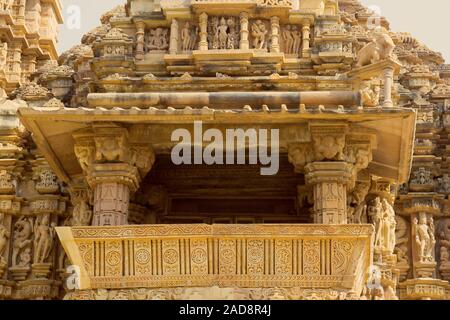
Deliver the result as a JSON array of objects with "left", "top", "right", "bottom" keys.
[{"left": 413, "top": 213, "right": 436, "bottom": 262}]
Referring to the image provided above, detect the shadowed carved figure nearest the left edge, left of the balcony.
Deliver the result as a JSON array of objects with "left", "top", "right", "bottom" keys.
[{"left": 12, "top": 216, "right": 33, "bottom": 267}]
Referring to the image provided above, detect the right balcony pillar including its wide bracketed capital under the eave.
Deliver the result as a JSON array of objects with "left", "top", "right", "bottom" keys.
[{"left": 288, "top": 123, "right": 376, "bottom": 224}]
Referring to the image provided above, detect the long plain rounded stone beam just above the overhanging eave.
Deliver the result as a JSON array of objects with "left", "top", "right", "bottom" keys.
[{"left": 88, "top": 91, "right": 361, "bottom": 109}]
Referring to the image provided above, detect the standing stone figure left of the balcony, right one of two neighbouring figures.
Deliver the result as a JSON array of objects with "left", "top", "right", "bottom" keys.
[{"left": 34, "top": 215, "right": 54, "bottom": 263}]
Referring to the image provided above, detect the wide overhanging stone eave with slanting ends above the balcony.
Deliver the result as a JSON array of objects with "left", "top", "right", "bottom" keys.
[{"left": 18, "top": 108, "right": 416, "bottom": 183}]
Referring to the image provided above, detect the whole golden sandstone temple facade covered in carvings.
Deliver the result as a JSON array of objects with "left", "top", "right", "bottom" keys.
[{"left": 0, "top": 0, "right": 450, "bottom": 300}]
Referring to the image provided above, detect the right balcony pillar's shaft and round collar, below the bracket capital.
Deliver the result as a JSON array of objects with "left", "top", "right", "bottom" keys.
[{"left": 305, "top": 162, "right": 353, "bottom": 224}]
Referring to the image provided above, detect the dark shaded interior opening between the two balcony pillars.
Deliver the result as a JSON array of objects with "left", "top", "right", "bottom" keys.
[{"left": 130, "top": 154, "right": 312, "bottom": 224}]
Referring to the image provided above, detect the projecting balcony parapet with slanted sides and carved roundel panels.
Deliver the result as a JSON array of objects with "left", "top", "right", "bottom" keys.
[{"left": 57, "top": 224, "right": 373, "bottom": 294}]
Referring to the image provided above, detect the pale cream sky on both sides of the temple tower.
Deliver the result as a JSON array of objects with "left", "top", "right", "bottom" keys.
[{"left": 59, "top": 0, "right": 450, "bottom": 63}]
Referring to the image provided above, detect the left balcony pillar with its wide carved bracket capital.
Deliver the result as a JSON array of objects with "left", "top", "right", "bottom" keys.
[{"left": 74, "top": 124, "right": 155, "bottom": 226}]
